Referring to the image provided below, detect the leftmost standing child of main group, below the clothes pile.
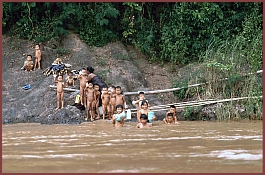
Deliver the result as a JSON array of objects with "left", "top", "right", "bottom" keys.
[{"left": 53, "top": 75, "right": 65, "bottom": 109}]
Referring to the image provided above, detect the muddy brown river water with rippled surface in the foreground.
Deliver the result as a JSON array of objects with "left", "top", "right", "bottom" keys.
[{"left": 2, "top": 120, "right": 263, "bottom": 173}]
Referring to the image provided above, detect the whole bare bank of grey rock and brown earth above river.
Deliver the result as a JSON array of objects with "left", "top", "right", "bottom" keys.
[{"left": 2, "top": 34, "right": 260, "bottom": 124}]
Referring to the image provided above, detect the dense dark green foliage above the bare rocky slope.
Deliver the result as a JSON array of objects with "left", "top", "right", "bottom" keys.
[{"left": 2, "top": 2, "right": 262, "bottom": 67}]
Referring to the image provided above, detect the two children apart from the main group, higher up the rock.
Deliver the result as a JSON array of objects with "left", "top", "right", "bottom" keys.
[{"left": 21, "top": 44, "right": 41, "bottom": 71}]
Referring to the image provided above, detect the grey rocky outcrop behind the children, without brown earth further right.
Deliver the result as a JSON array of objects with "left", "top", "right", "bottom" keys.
[{"left": 2, "top": 34, "right": 165, "bottom": 124}]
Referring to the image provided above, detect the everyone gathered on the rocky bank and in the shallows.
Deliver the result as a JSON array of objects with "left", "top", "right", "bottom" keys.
[{"left": 22, "top": 44, "right": 178, "bottom": 128}]
